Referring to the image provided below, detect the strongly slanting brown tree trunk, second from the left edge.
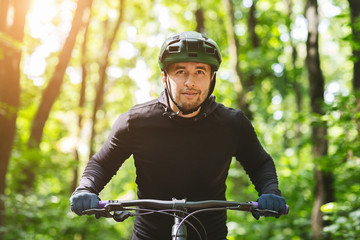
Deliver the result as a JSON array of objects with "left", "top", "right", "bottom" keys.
[{"left": 20, "top": 0, "right": 92, "bottom": 191}]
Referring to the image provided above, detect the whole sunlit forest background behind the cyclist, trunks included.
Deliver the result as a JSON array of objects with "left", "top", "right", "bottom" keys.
[{"left": 0, "top": 0, "right": 360, "bottom": 240}]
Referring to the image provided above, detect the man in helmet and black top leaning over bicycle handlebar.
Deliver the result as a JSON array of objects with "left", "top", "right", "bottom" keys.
[{"left": 70, "top": 32, "right": 286, "bottom": 240}]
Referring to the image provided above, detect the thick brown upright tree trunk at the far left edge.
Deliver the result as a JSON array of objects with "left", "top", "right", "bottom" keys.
[{"left": 0, "top": 0, "right": 30, "bottom": 234}]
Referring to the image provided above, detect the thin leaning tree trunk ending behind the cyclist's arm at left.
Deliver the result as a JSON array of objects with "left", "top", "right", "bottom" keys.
[{"left": 89, "top": 0, "right": 125, "bottom": 158}]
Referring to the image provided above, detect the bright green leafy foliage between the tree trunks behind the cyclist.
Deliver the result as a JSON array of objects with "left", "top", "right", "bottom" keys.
[{"left": 0, "top": 0, "right": 360, "bottom": 240}]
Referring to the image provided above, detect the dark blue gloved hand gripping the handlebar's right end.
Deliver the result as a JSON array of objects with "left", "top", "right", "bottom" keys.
[{"left": 253, "top": 194, "right": 286, "bottom": 220}]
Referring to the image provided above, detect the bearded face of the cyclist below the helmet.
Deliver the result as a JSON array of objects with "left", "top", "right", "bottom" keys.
[{"left": 162, "top": 62, "right": 212, "bottom": 117}]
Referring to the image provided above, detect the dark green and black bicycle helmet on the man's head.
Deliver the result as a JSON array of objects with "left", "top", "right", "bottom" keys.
[{"left": 159, "top": 31, "right": 221, "bottom": 71}]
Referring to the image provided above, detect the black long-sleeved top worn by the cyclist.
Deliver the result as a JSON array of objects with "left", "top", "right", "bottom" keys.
[{"left": 75, "top": 93, "right": 281, "bottom": 240}]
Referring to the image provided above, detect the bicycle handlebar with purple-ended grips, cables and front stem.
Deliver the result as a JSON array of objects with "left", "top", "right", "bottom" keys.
[{"left": 83, "top": 198, "right": 289, "bottom": 240}]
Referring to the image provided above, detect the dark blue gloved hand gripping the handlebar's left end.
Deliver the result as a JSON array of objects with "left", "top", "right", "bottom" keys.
[{"left": 70, "top": 192, "right": 100, "bottom": 216}]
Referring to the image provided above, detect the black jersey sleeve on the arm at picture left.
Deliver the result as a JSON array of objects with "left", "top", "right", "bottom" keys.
[{"left": 73, "top": 112, "right": 132, "bottom": 194}]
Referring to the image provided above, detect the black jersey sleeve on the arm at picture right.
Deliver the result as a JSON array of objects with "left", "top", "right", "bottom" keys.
[{"left": 235, "top": 111, "right": 281, "bottom": 196}]
